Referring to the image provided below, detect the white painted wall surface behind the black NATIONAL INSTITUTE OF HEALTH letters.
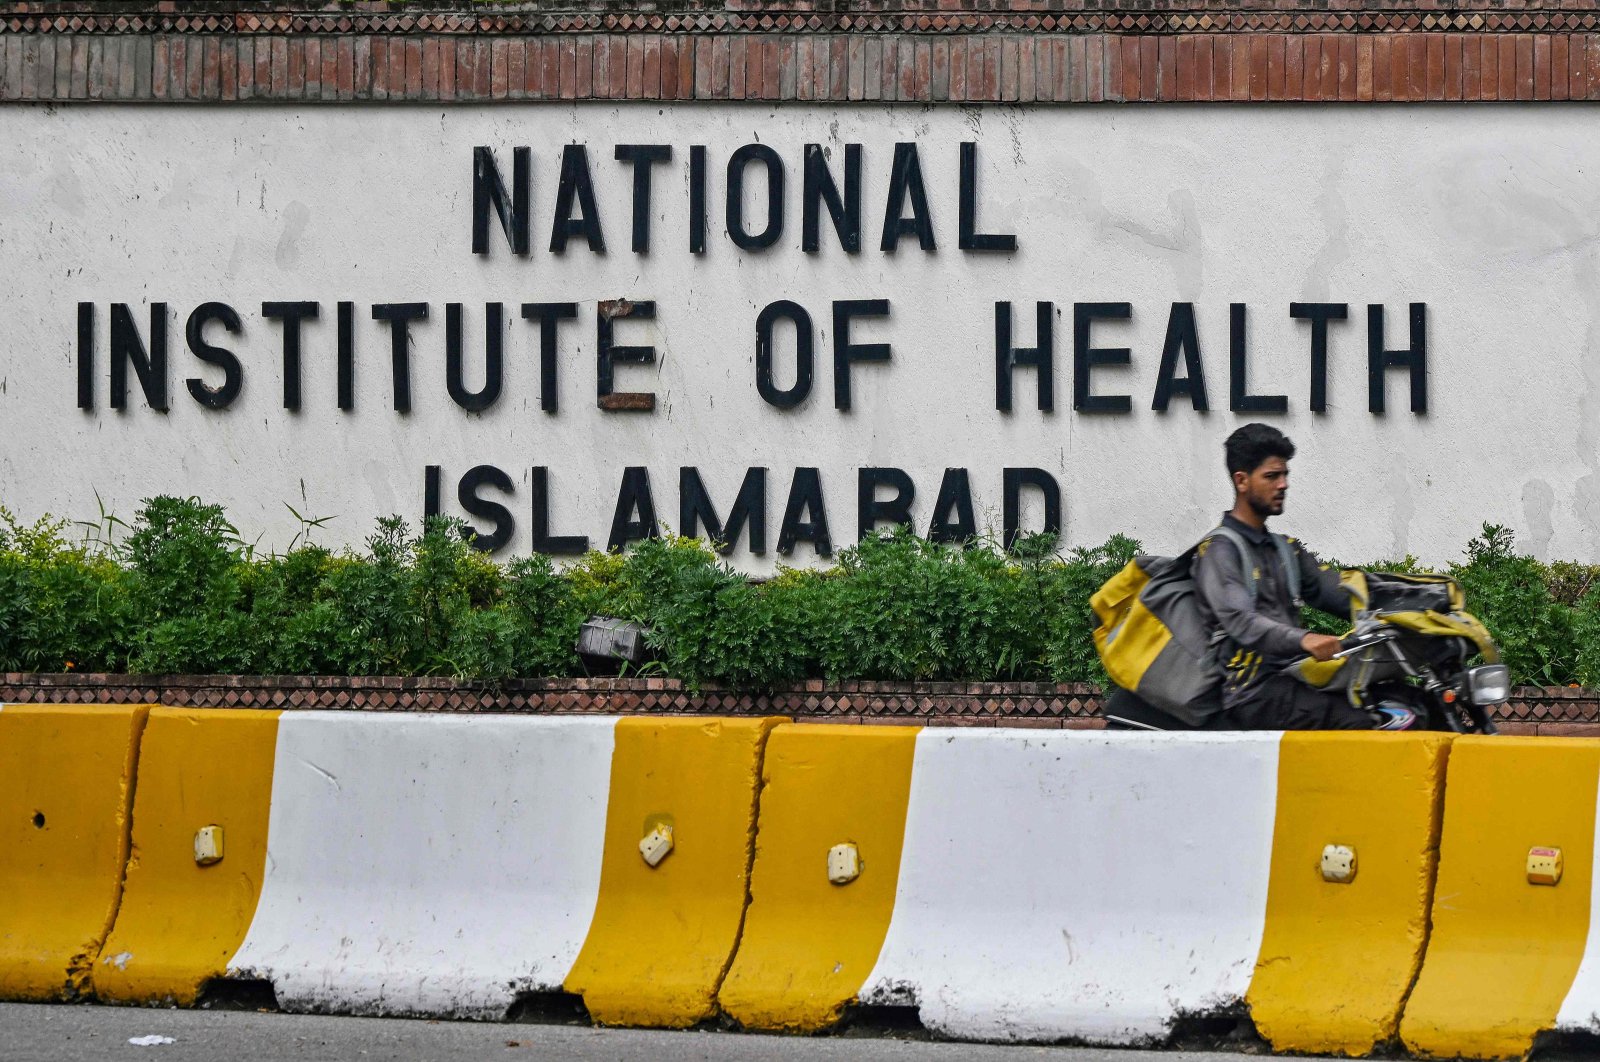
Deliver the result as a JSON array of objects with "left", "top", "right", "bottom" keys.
[{"left": 0, "top": 104, "right": 1600, "bottom": 571}]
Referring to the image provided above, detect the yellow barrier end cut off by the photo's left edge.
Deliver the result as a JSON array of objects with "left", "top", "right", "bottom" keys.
[{"left": 0, "top": 705, "right": 149, "bottom": 1000}]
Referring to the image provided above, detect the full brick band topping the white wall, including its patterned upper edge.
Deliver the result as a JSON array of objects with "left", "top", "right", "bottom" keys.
[{"left": 0, "top": 0, "right": 1600, "bottom": 102}]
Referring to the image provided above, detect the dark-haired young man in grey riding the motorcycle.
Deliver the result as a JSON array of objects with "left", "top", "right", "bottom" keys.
[{"left": 1194, "top": 424, "right": 1413, "bottom": 729}]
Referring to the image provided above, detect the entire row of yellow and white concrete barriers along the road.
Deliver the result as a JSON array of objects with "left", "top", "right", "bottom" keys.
[{"left": 25, "top": 705, "right": 1574, "bottom": 1057}]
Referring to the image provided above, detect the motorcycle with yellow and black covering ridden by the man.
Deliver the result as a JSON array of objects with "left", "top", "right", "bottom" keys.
[{"left": 1101, "top": 571, "right": 1510, "bottom": 734}]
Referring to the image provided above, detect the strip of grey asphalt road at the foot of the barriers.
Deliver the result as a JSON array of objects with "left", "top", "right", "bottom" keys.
[{"left": 0, "top": 1004, "right": 1251, "bottom": 1062}]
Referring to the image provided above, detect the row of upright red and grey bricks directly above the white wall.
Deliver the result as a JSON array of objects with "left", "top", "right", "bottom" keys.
[{"left": 0, "top": 34, "right": 1600, "bottom": 104}]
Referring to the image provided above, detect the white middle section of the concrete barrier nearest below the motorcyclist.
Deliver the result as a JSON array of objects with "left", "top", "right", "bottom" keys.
[{"left": 859, "top": 729, "right": 1278, "bottom": 1043}]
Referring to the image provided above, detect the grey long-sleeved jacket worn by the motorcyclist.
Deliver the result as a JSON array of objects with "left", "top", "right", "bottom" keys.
[{"left": 1194, "top": 513, "right": 1350, "bottom": 707}]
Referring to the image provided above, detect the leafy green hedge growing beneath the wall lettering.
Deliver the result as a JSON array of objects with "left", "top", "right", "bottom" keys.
[{"left": 0, "top": 497, "right": 1600, "bottom": 688}]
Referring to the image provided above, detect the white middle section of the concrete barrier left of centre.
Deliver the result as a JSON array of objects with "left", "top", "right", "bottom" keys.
[{"left": 229, "top": 712, "right": 614, "bottom": 1019}]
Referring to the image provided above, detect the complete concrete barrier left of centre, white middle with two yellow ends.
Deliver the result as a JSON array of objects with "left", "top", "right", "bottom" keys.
[{"left": 94, "top": 710, "right": 771, "bottom": 1025}]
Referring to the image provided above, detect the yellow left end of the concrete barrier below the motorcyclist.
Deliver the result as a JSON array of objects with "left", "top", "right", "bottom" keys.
[{"left": 717, "top": 725, "right": 921, "bottom": 1032}]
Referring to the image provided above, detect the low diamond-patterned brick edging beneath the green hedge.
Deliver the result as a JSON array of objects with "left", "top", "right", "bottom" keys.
[{"left": 0, "top": 673, "right": 1600, "bottom": 737}]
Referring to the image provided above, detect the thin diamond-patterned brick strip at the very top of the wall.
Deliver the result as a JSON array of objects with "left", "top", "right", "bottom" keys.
[{"left": 9, "top": 0, "right": 1600, "bottom": 37}]
